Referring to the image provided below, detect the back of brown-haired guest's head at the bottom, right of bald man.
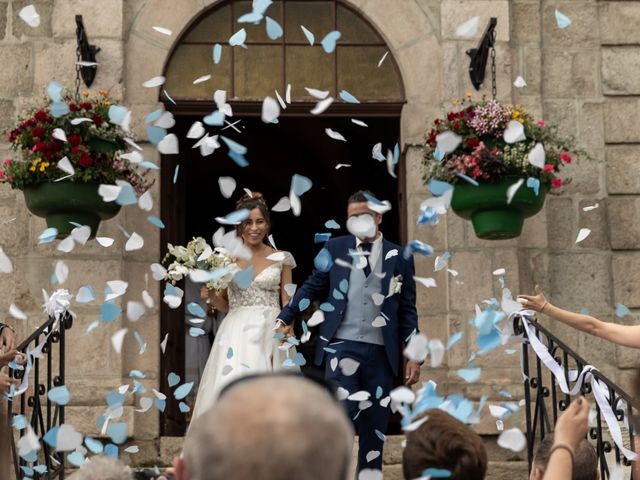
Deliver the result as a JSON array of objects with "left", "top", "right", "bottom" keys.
[{"left": 402, "top": 409, "right": 487, "bottom": 480}]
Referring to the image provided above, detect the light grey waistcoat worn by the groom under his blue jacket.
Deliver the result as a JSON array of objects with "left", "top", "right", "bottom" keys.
[{"left": 335, "top": 251, "right": 384, "bottom": 345}]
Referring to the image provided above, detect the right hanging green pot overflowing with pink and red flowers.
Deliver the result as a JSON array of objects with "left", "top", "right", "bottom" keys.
[{"left": 423, "top": 94, "right": 582, "bottom": 240}]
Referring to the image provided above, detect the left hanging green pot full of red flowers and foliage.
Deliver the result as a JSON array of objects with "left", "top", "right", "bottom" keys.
[{"left": 0, "top": 82, "right": 153, "bottom": 238}]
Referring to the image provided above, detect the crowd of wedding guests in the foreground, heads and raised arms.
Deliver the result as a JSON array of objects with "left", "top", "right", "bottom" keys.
[{"left": 7, "top": 280, "right": 640, "bottom": 480}]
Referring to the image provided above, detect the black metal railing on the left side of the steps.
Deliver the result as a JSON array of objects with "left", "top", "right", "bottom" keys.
[{"left": 8, "top": 313, "right": 73, "bottom": 480}]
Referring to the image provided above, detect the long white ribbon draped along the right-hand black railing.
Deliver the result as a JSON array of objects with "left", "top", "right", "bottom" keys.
[{"left": 510, "top": 310, "right": 638, "bottom": 461}]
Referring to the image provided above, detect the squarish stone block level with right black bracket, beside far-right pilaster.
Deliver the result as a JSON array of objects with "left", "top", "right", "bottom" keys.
[{"left": 542, "top": 47, "right": 600, "bottom": 98}]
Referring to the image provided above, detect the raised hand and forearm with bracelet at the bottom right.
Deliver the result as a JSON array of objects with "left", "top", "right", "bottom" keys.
[{"left": 542, "top": 396, "right": 589, "bottom": 480}]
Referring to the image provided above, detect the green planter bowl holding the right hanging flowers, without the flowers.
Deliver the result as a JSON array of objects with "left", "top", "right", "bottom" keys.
[{"left": 451, "top": 177, "right": 549, "bottom": 240}]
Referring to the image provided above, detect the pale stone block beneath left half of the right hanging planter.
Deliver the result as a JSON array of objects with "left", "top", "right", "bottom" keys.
[{"left": 449, "top": 251, "right": 494, "bottom": 311}]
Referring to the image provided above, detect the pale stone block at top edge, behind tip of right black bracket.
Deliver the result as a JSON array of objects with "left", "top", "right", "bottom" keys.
[{"left": 440, "top": 0, "right": 512, "bottom": 42}]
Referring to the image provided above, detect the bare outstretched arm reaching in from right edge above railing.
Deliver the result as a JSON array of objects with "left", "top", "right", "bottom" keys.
[{"left": 518, "top": 285, "right": 640, "bottom": 348}]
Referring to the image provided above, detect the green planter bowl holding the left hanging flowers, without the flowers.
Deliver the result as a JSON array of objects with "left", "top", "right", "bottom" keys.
[{"left": 23, "top": 182, "right": 120, "bottom": 238}]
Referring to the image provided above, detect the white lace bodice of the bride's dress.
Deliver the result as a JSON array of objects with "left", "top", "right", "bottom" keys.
[{"left": 227, "top": 252, "right": 295, "bottom": 310}]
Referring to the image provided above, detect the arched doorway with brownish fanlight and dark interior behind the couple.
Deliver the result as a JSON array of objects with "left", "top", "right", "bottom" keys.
[{"left": 160, "top": 0, "right": 406, "bottom": 435}]
